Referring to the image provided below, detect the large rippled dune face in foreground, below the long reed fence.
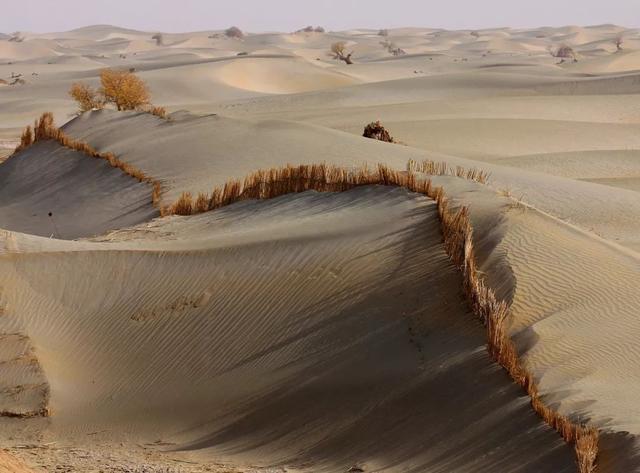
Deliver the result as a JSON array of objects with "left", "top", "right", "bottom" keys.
[{"left": 0, "top": 187, "right": 573, "bottom": 472}]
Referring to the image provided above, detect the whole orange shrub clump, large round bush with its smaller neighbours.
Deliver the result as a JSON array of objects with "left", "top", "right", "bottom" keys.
[{"left": 69, "top": 69, "right": 166, "bottom": 118}]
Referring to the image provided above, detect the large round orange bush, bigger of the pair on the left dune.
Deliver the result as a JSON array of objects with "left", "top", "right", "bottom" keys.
[{"left": 100, "top": 69, "right": 149, "bottom": 110}]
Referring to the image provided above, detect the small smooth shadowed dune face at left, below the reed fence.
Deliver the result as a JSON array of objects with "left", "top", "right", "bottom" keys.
[{"left": 0, "top": 141, "right": 157, "bottom": 239}]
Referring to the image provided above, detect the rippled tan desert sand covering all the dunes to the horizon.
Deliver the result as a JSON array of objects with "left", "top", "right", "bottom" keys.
[{"left": 0, "top": 25, "right": 640, "bottom": 473}]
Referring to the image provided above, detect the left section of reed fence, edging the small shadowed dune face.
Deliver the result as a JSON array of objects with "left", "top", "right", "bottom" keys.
[{"left": 15, "top": 112, "right": 162, "bottom": 208}]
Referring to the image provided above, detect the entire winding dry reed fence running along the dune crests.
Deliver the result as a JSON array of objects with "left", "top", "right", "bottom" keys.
[{"left": 16, "top": 113, "right": 599, "bottom": 473}]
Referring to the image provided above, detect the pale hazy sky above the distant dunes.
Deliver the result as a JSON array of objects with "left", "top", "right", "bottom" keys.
[{"left": 5, "top": 0, "right": 640, "bottom": 33}]
